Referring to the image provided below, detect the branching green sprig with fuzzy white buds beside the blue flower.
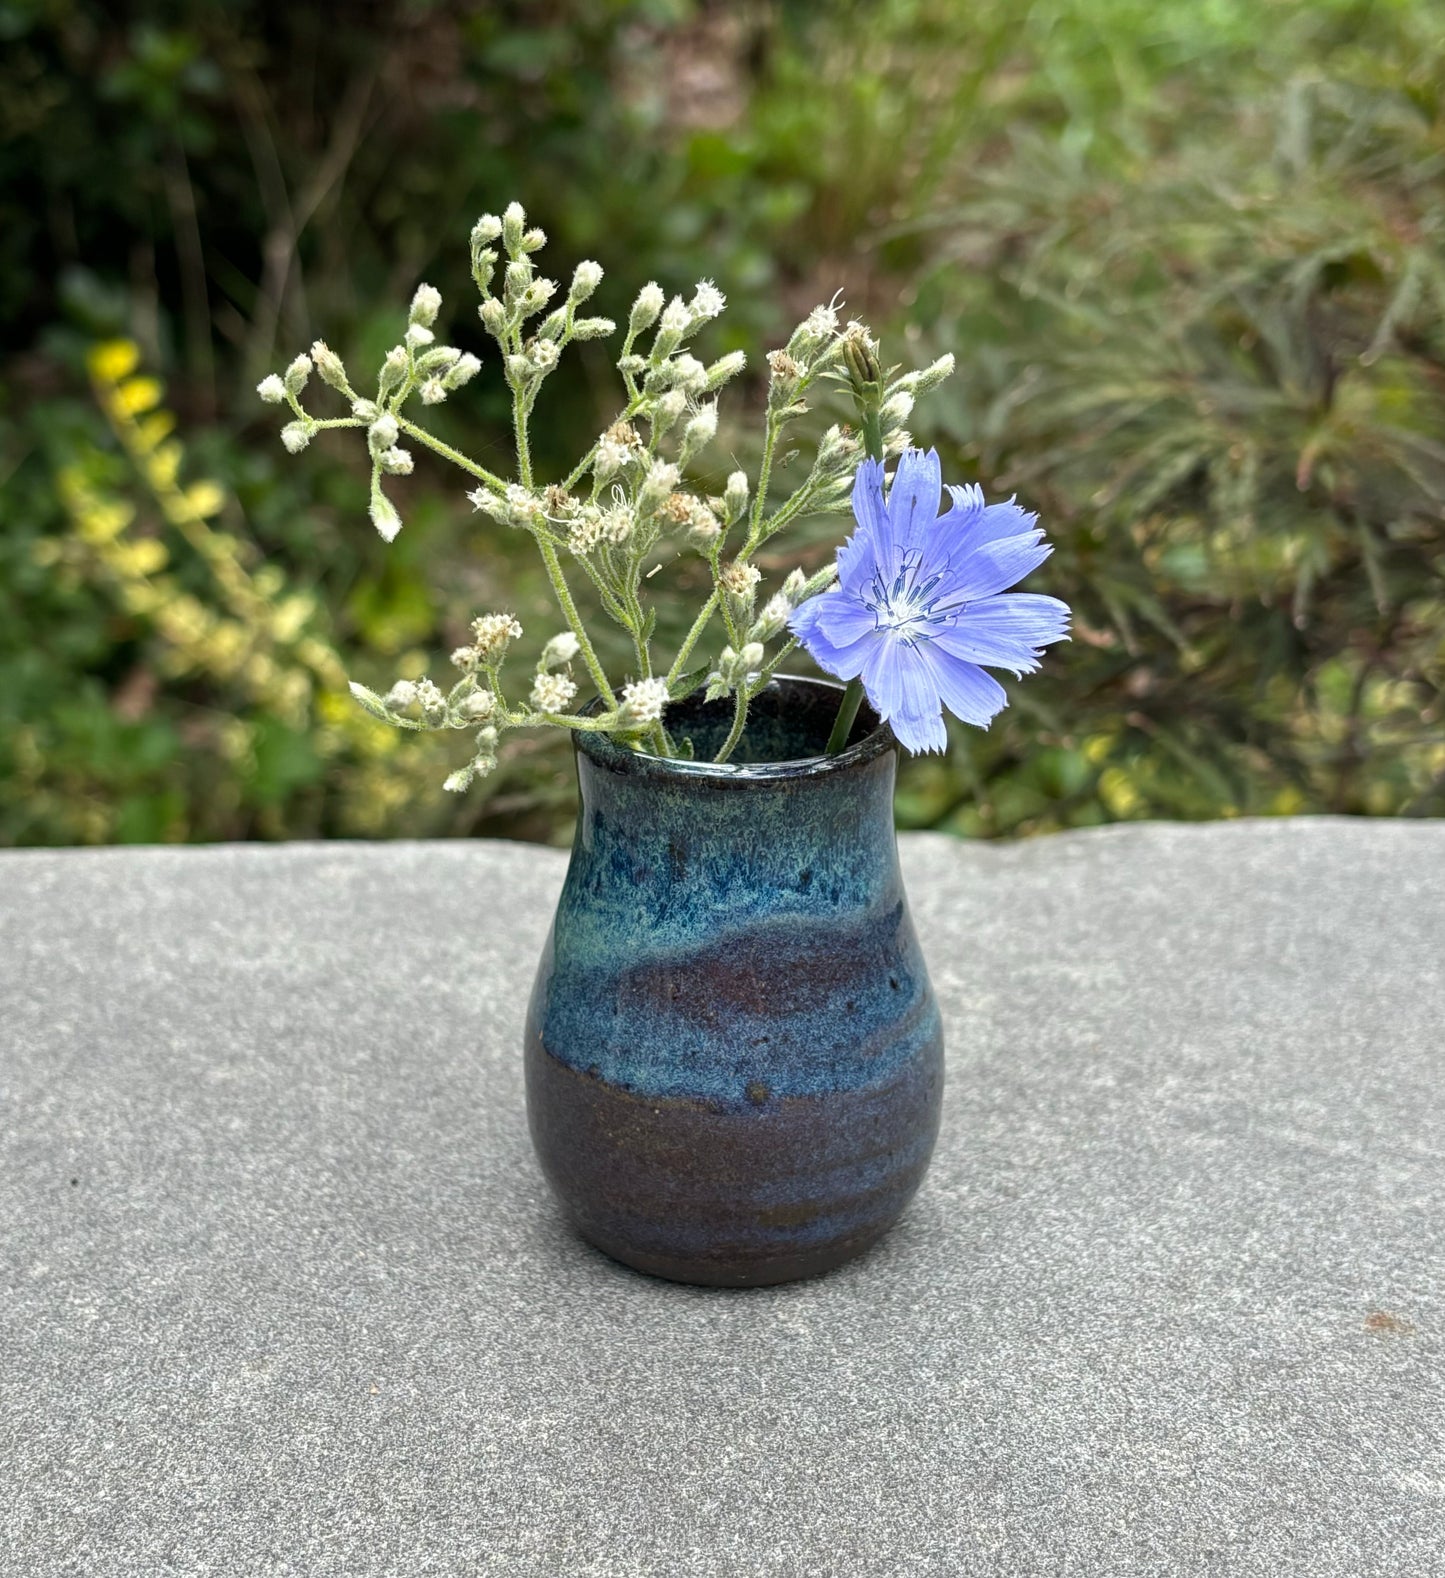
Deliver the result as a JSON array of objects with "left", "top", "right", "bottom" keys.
[{"left": 257, "top": 204, "right": 953, "bottom": 791}]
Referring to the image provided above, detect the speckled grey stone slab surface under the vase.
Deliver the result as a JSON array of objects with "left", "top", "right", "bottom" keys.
[{"left": 0, "top": 821, "right": 1445, "bottom": 1578}]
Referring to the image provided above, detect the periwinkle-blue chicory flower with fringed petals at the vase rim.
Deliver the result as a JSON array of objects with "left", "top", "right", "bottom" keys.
[{"left": 789, "top": 450, "right": 1070, "bottom": 751}]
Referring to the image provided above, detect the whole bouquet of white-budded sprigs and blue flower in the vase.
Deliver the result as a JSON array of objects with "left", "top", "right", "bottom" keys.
[{"left": 259, "top": 204, "right": 1068, "bottom": 791}]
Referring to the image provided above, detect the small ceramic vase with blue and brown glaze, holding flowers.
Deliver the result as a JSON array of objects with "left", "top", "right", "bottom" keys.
[{"left": 525, "top": 679, "right": 943, "bottom": 1286}]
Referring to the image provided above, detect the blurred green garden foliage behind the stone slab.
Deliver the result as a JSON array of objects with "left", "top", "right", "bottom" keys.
[{"left": 0, "top": 0, "right": 1445, "bottom": 843}]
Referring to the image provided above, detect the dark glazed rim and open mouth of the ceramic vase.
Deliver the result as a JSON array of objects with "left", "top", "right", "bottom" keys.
[{"left": 573, "top": 674, "right": 898, "bottom": 784}]
